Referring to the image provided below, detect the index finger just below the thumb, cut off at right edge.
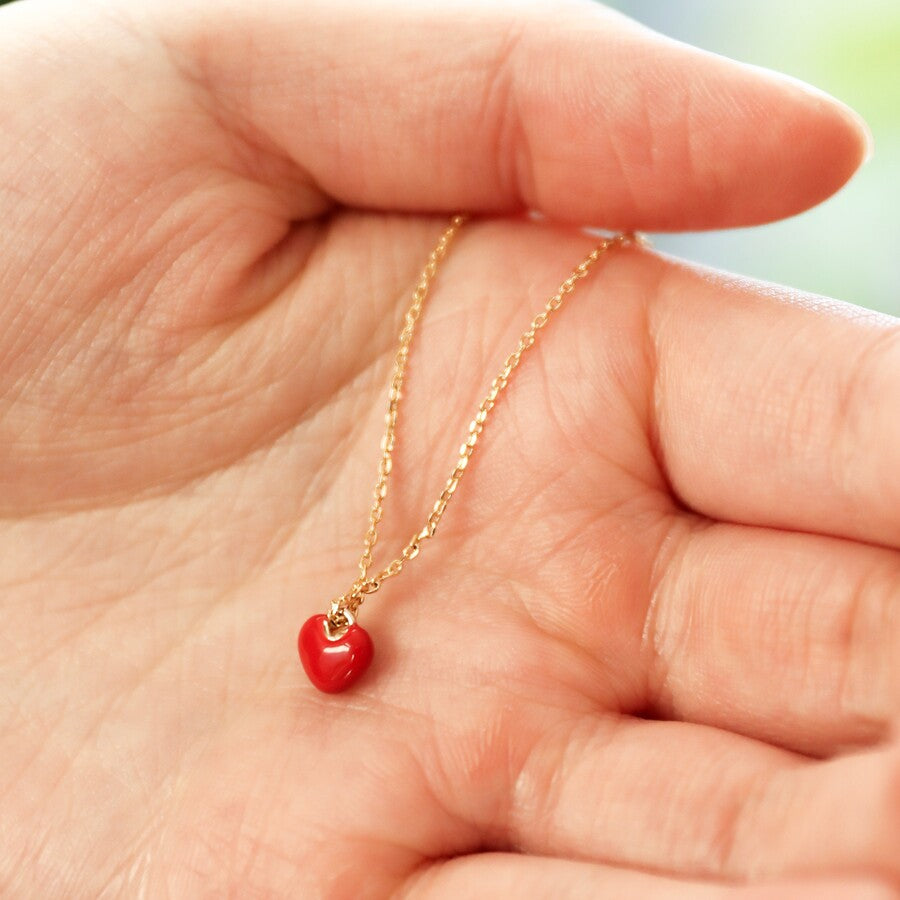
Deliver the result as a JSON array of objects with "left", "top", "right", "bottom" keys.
[{"left": 628, "top": 246, "right": 900, "bottom": 546}]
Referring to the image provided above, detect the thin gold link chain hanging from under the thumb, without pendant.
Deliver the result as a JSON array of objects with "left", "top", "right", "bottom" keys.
[{"left": 328, "top": 215, "right": 645, "bottom": 629}]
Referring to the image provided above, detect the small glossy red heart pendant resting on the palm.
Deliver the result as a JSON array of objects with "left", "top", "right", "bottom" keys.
[{"left": 297, "top": 615, "right": 375, "bottom": 694}]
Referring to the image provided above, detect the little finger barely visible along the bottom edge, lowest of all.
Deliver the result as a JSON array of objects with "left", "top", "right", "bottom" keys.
[{"left": 397, "top": 853, "right": 898, "bottom": 900}]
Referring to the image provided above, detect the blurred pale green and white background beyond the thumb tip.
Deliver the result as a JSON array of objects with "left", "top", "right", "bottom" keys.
[{"left": 607, "top": 0, "right": 900, "bottom": 315}]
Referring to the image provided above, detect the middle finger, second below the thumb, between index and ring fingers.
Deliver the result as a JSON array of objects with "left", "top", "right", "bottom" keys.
[{"left": 644, "top": 523, "right": 900, "bottom": 754}]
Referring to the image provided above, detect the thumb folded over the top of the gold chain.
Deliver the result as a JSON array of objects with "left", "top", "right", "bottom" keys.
[{"left": 128, "top": 0, "right": 866, "bottom": 229}]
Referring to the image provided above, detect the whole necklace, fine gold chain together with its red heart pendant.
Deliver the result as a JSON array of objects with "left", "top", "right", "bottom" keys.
[{"left": 297, "top": 215, "right": 643, "bottom": 694}]
